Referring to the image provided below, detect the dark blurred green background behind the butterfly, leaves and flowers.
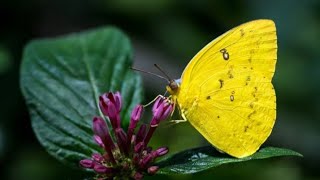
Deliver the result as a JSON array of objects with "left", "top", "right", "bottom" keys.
[{"left": 0, "top": 0, "right": 320, "bottom": 180}]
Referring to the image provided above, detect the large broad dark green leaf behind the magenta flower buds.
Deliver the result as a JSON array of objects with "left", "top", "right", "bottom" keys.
[{"left": 20, "top": 27, "right": 142, "bottom": 166}]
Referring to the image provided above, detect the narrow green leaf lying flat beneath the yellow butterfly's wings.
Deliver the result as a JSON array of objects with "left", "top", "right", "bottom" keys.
[{"left": 158, "top": 146, "right": 302, "bottom": 174}]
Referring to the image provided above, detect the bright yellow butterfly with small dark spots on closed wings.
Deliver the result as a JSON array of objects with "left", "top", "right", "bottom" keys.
[{"left": 167, "top": 20, "right": 277, "bottom": 158}]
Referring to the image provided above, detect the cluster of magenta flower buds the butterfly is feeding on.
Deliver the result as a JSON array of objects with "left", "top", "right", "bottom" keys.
[{"left": 80, "top": 92, "right": 173, "bottom": 180}]
